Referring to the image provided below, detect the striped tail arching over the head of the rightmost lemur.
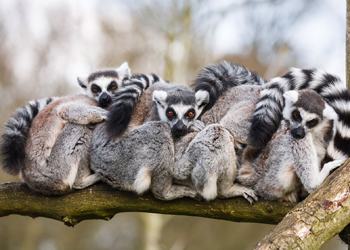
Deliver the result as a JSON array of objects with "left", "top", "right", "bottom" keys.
[{"left": 249, "top": 68, "right": 350, "bottom": 159}]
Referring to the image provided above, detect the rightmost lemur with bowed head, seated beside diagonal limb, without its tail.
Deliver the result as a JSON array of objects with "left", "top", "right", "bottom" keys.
[{"left": 237, "top": 90, "right": 338, "bottom": 202}]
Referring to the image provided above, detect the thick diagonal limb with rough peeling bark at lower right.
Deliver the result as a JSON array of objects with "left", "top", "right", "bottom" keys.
[{"left": 255, "top": 160, "right": 350, "bottom": 249}]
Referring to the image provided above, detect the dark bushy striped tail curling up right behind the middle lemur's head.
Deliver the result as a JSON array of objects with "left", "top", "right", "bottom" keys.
[{"left": 194, "top": 61, "right": 265, "bottom": 113}]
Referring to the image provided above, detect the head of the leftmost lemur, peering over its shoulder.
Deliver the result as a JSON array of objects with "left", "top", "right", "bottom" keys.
[{"left": 78, "top": 62, "right": 131, "bottom": 107}]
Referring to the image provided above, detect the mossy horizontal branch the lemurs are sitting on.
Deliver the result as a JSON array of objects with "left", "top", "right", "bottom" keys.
[{"left": 0, "top": 182, "right": 294, "bottom": 226}]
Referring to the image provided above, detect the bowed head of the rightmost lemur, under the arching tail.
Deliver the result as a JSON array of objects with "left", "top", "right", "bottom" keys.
[{"left": 283, "top": 90, "right": 338, "bottom": 139}]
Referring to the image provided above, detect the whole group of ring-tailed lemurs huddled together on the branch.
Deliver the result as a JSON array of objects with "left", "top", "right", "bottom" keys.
[{"left": 0, "top": 61, "right": 350, "bottom": 203}]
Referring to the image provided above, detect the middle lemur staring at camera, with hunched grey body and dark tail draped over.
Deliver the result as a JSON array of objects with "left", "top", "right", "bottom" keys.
[{"left": 91, "top": 82, "right": 209, "bottom": 200}]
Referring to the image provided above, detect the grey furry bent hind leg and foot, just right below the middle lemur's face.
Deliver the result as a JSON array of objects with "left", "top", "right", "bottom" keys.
[{"left": 186, "top": 124, "right": 257, "bottom": 203}]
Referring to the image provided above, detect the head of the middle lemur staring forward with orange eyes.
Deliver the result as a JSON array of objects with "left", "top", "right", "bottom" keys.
[{"left": 153, "top": 85, "right": 209, "bottom": 136}]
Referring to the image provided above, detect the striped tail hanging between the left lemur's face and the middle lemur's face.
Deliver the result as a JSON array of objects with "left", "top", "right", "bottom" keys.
[{"left": 106, "top": 74, "right": 166, "bottom": 138}]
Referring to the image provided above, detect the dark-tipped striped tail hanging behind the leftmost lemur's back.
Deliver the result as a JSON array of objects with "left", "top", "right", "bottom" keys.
[{"left": 0, "top": 98, "right": 55, "bottom": 175}]
